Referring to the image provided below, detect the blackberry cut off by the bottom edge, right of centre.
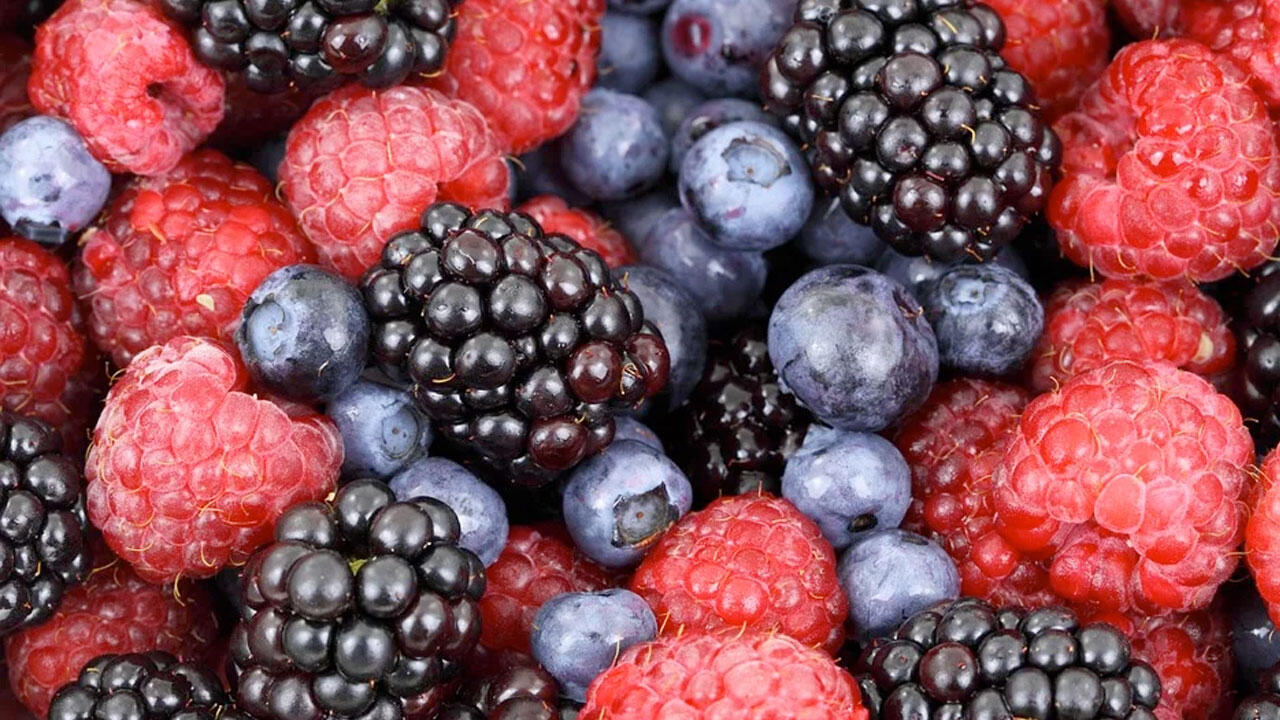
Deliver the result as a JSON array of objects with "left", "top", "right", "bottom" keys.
[{"left": 854, "top": 598, "right": 1160, "bottom": 720}]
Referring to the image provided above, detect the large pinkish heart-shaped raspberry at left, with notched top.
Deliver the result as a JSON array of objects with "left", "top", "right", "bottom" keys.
[{"left": 84, "top": 337, "right": 342, "bottom": 583}]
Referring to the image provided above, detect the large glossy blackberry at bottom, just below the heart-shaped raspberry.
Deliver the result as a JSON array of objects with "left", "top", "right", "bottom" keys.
[{"left": 230, "top": 480, "right": 484, "bottom": 720}]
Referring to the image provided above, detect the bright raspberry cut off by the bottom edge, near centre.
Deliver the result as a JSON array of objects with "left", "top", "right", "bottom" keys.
[{"left": 577, "top": 632, "right": 870, "bottom": 720}]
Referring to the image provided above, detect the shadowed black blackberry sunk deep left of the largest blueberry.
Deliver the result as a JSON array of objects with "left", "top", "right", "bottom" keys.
[{"left": 663, "top": 325, "right": 812, "bottom": 501}]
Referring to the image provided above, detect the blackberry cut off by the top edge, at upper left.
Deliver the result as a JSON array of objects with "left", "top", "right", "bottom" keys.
[{"left": 160, "top": 0, "right": 462, "bottom": 92}]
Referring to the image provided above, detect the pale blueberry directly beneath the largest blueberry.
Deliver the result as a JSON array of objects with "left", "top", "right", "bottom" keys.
[{"left": 782, "top": 425, "right": 911, "bottom": 550}]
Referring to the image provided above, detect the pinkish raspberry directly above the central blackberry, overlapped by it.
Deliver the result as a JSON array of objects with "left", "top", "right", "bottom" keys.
[{"left": 280, "top": 85, "right": 511, "bottom": 278}]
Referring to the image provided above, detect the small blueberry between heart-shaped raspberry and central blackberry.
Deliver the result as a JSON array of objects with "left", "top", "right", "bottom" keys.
[{"left": 325, "top": 379, "right": 431, "bottom": 480}]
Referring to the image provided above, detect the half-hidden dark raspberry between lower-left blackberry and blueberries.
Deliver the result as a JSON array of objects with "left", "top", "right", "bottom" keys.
[{"left": 480, "top": 525, "right": 611, "bottom": 653}]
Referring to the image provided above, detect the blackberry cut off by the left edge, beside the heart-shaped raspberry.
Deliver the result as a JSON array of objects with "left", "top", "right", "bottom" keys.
[{"left": 0, "top": 411, "right": 92, "bottom": 635}]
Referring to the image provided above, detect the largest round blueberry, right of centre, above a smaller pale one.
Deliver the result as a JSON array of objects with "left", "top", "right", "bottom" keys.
[{"left": 769, "top": 265, "right": 938, "bottom": 432}]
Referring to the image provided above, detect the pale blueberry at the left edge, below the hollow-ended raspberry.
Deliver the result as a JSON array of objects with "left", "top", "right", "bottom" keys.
[{"left": 0, "top": 115, "right": 111, "bottom": 245}]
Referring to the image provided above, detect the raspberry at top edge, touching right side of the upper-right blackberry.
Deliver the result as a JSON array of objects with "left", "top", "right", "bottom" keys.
[{"left": 987, "top": 0, "right": 1111, "bottom": 120}]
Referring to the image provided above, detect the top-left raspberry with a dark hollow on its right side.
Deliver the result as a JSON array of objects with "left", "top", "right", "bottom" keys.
[{"left": 27, "top": 0, "right": 225, "bottom": 176}]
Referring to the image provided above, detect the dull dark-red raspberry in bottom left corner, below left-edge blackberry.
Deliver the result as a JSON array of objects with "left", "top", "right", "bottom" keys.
[{"left": 4, "top": 551, "right": 216, "bottom": 717}]
